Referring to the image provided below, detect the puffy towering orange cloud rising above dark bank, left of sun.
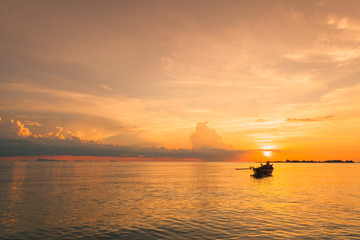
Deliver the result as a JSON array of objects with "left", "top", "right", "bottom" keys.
[{"left": 190, "top": 122, "right": 232, "bottom": 149}]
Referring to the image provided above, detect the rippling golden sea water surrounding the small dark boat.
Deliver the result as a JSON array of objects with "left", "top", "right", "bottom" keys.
[{"left": 0, "top": 162, "right": 360, "bottom": 239}]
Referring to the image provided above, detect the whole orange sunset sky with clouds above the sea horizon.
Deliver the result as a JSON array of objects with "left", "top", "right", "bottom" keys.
[{"left": 0, "top": 0, "right": 360, "bottom": 161}]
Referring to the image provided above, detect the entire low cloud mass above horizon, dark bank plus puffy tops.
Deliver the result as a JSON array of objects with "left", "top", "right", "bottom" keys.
[{"left": 0, "top": 120, "right": 249, "bottom": 161}]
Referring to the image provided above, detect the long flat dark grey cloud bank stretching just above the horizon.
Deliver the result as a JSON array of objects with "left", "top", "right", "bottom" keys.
[{"left": 0, "top": 138, "right": 247, "bottom": 161}]
